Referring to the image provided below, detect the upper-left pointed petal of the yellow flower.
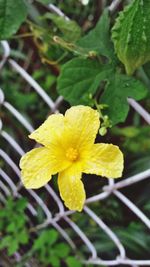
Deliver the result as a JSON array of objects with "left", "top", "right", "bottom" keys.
[{"left": 29, "top": 114, "right": 64, "bottom": 147}]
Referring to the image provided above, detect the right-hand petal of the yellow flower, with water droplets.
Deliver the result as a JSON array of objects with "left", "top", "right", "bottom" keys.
[{"left": 83, "top": 144, "right": 123, "bottom": 178}]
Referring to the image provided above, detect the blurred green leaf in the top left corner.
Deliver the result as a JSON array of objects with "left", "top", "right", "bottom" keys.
[{"left": 0, "top": 0, "right": 27, "bottom": 40}]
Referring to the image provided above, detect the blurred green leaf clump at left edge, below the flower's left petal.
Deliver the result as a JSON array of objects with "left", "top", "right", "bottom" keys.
[{"left": 0, "top": 198, "right": 29, "bottom": 256}]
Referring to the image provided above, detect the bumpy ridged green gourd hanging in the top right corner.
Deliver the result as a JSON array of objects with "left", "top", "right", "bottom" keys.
[{"left": 112, "top": 0, "right": 150, "bottom": 75}]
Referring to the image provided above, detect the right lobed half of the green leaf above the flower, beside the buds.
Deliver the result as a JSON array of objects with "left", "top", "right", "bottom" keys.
[{"left": 100, "top": 74, "right": 147, "bottom": 125}]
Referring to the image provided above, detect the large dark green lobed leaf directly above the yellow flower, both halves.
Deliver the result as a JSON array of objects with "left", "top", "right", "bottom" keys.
[{"left": 58, "top": 58, "right": 147, "bottom": 125}]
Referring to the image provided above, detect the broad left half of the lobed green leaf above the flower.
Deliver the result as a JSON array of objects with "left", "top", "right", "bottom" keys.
[{"left": 58, "top": 58, "right": 112, "bottom": 105}]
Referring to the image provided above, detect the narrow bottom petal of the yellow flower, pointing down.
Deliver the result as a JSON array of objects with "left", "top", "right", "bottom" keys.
[{"left": 58, "top": 168, "right": 85, "bottom": 211}]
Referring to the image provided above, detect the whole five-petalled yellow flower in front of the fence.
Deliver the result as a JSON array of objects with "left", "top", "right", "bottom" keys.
[{"left": 20, "top": 106, "right": 123, "bottom": 211}]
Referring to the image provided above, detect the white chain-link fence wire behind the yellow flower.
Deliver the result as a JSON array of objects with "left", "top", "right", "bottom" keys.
[{"left": 0, "top": 33, "right": 150, "bottom": 267}]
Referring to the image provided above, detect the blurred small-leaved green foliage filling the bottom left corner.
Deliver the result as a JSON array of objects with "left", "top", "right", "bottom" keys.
[{"left": 0, "top": 197, "right": 82, "bottom": 267}]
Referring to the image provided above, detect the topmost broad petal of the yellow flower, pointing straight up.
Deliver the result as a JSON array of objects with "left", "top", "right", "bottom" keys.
[{"left": 65, "top": 106, "right": 100, "bottom": 149}]
